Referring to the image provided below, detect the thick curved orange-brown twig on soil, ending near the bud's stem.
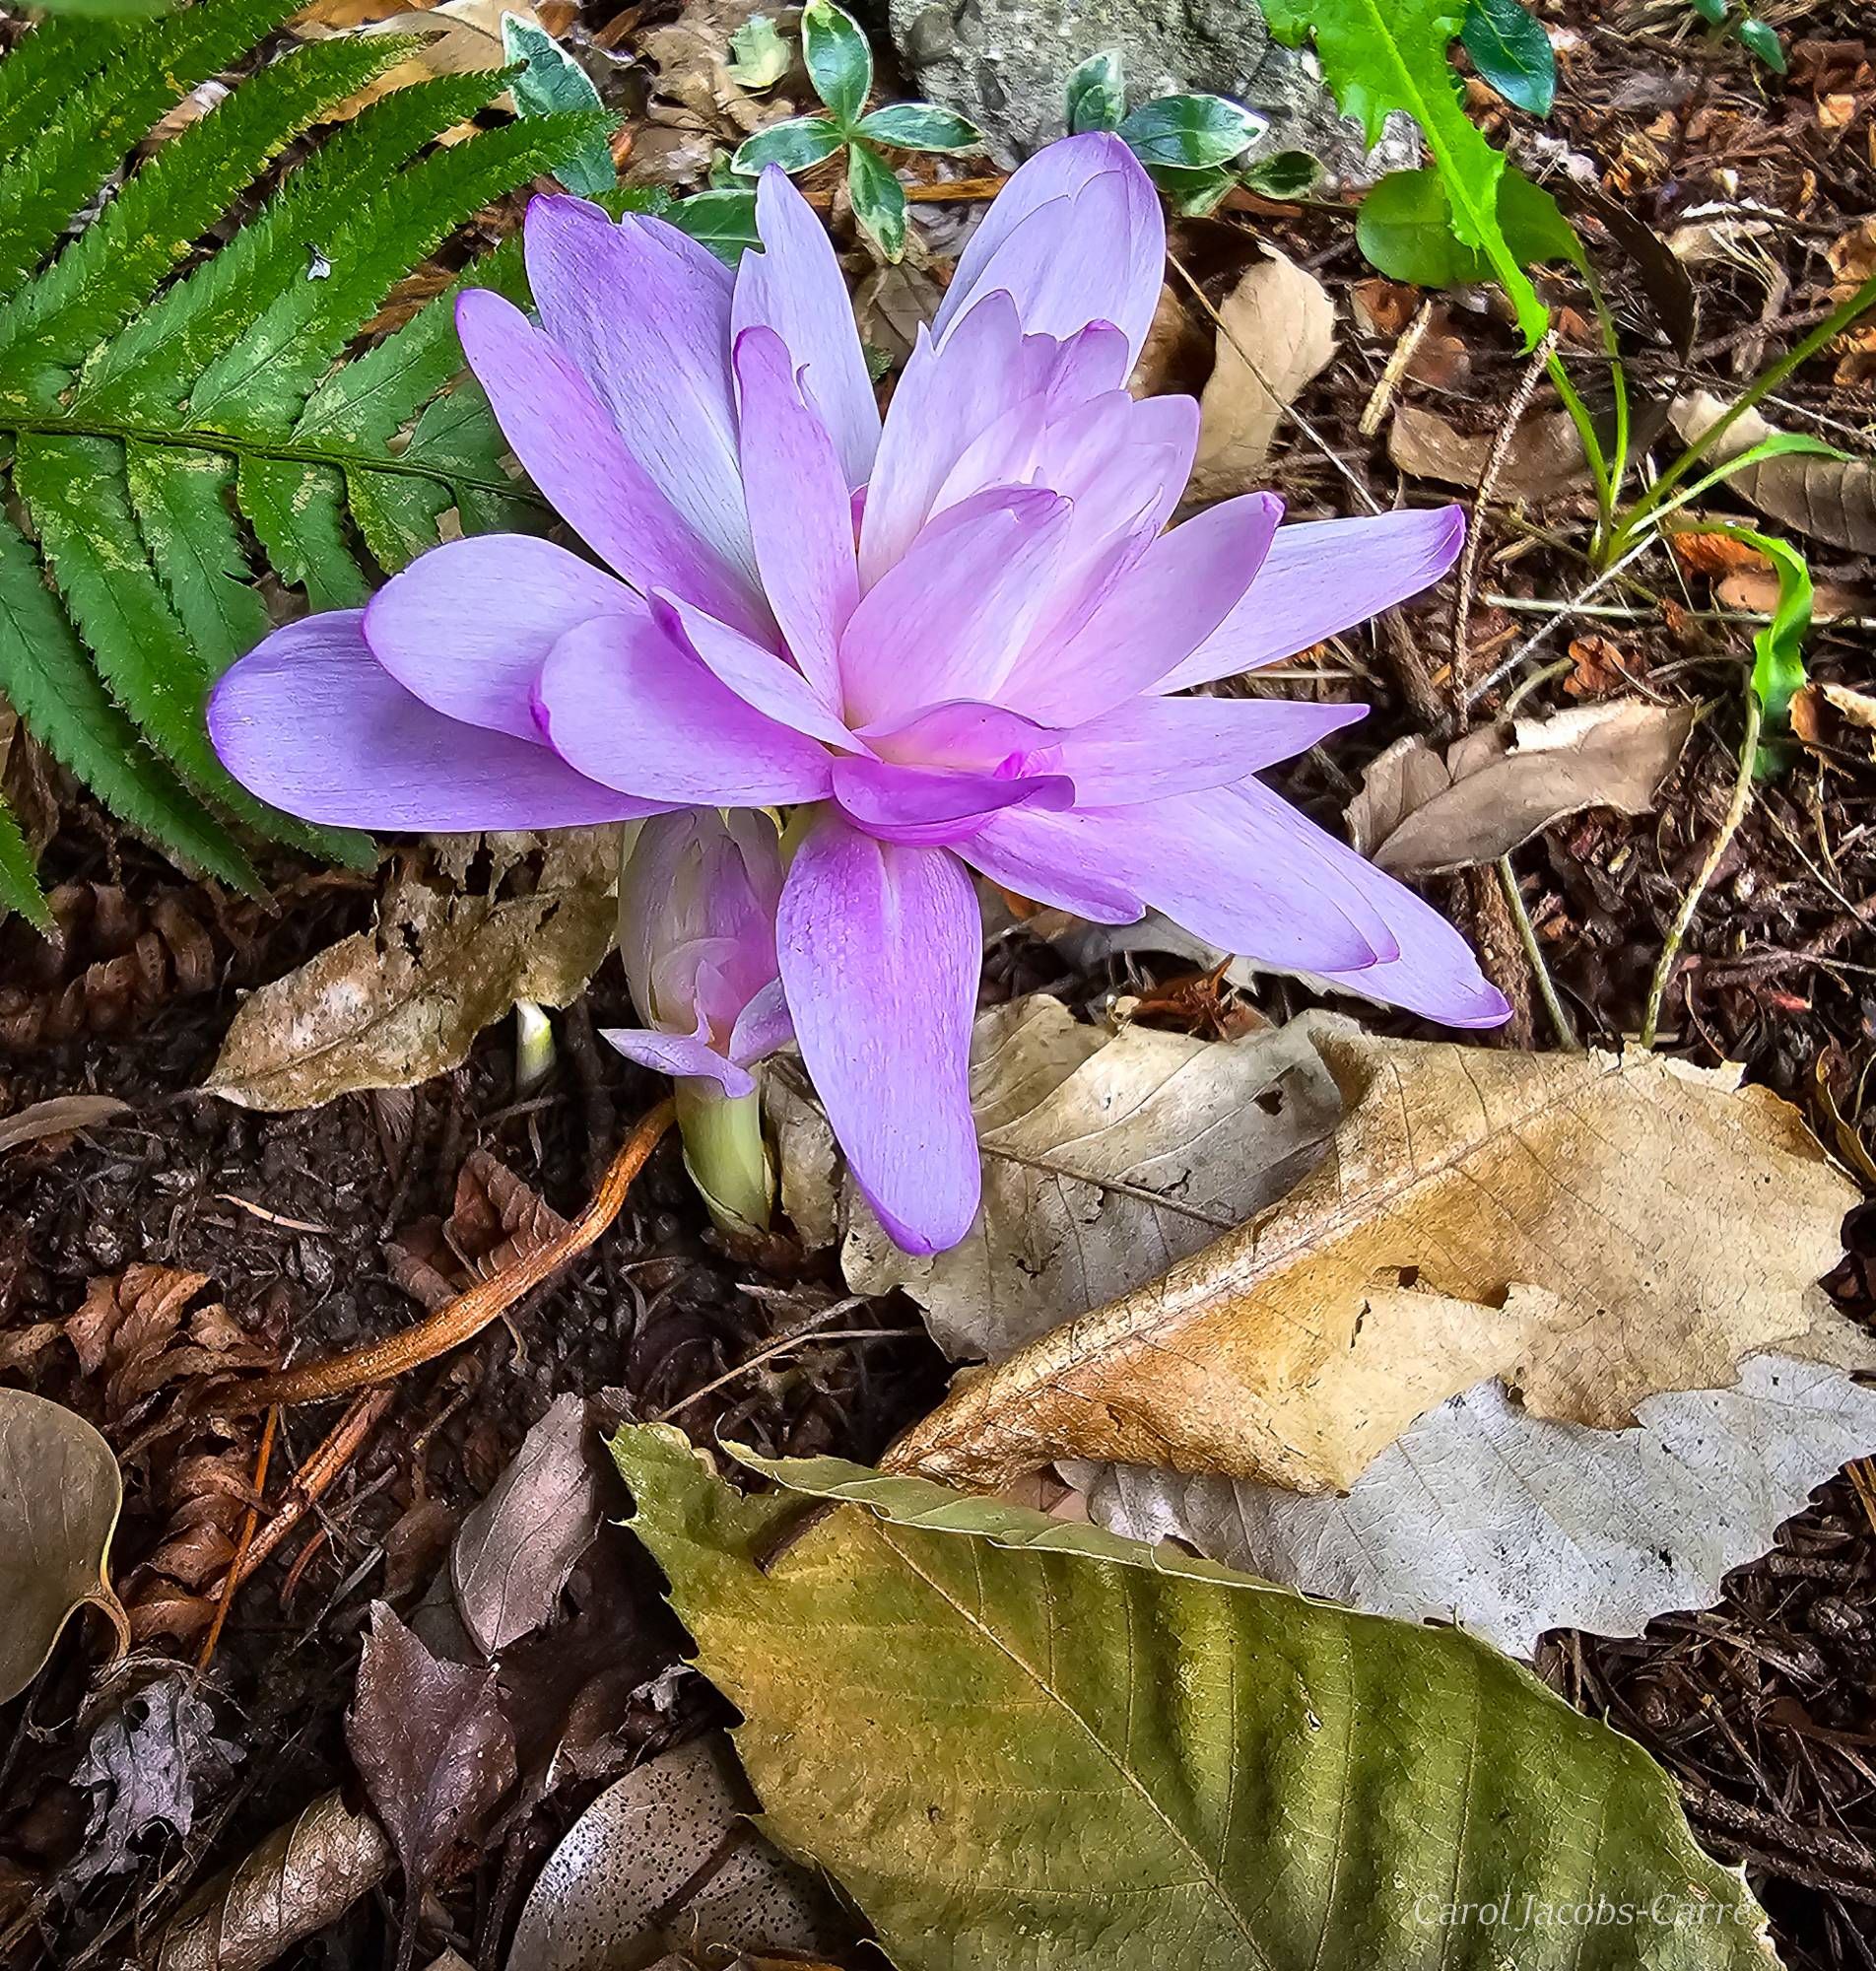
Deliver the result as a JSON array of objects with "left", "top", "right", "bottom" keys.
[{"left": 203, "top": 1100, "right": 674, "bottom": 1415}]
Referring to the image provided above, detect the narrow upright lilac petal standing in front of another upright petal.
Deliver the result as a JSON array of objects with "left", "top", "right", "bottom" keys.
[{"left": 735, "top": 327, "right": 859, "bottom": 712}]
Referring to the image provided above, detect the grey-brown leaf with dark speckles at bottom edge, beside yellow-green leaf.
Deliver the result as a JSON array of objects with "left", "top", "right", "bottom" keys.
[{"left": 508, "top": 1734, "right": 832, "bottom": 1971}]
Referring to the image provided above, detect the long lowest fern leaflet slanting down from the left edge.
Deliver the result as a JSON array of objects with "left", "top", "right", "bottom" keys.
[{"left": 0, "top": 501, "right": 260, "bottom": 893}]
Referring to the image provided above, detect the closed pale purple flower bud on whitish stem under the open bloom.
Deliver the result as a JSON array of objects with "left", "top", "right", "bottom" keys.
[{"left": 601, "top": 808, "right": 792, "bottom": 1232}]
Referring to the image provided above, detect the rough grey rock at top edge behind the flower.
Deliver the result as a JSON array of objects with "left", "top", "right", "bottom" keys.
[{"left": 887, "top": 0, "right": 1419, "bottom": 185}]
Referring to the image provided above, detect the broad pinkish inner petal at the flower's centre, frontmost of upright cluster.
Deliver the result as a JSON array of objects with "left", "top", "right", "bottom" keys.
[{"left": 839, "top": 487, "right": 1070, "bottom": 725}]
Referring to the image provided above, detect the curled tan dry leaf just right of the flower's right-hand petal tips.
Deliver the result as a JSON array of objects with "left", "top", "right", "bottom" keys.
[{"left": 1348, "top": 698, "right": 1697, "bottom": 875}]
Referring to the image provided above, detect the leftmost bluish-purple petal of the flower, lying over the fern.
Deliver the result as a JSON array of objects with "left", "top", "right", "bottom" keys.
[{"left": 209, "top": 609, "right": 658, "bottom": 834}]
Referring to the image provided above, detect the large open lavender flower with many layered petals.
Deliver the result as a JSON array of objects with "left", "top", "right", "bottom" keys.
[{"left": 211, "top": 134, "right": 1508, "bottom": 1252}]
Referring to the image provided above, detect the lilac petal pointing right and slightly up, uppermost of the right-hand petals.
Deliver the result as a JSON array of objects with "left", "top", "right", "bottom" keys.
[{"left": 1157, "top": 507, "right": 1466, "bottom": 692}]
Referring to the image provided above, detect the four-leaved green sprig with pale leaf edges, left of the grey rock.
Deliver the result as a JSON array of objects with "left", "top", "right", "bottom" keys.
[{"left": 729, "top": 0, "right": 983, "bottom": 260}]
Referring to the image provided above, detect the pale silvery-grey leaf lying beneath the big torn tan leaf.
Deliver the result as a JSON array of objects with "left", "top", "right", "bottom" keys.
[{"left": 1064, "top": 1354, "right": 1876, "bottom": 1656}]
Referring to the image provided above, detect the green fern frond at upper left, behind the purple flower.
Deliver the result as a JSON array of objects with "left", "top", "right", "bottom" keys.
[{"left": 0, "top": 0, "right": 631, "bottom": 915}]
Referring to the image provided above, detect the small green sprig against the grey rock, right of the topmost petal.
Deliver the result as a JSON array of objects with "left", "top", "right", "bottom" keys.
[{"left": 1064, "top": 49, "right": 1318, "bottom": 213}]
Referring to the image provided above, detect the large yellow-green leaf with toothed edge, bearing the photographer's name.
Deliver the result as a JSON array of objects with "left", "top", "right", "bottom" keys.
[{"left": 613, "top": 1429, "right": 1776, "bottom": 1971}]
